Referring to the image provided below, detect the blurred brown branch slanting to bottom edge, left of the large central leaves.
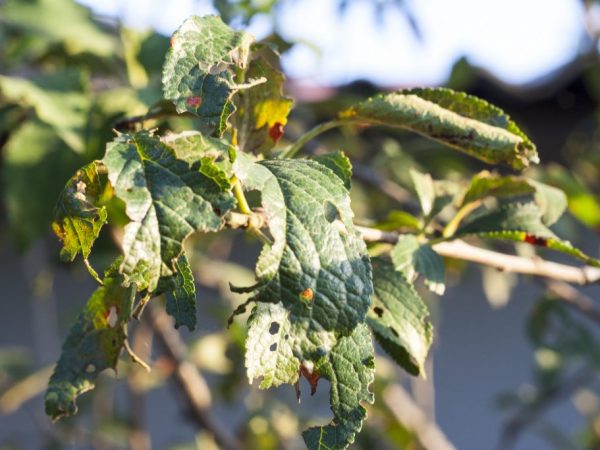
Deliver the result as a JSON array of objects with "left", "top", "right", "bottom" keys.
[{"left": 144, "top": 304, "right": 242, "bottom": 450}]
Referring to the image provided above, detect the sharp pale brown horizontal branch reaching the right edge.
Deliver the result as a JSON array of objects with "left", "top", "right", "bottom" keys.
[{"left": 357, "top": 227, "right": 600, "bottom": 285}]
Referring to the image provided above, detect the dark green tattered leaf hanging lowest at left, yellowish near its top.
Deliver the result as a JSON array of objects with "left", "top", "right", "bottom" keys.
[{"left": 45, "top": 264, "right": 135, "bottom": 420}]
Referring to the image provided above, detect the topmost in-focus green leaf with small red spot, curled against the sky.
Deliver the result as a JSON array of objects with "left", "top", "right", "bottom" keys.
[{"left": 162, "top": 16, "right": 254, "bottom": 135}]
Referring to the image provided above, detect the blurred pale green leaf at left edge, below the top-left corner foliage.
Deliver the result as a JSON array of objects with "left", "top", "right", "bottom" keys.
[{"left": 0, "top": 71, "right": 91, "bottom": 153}]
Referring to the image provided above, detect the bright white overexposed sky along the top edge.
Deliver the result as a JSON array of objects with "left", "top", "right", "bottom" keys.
[{"left": 81, "top": 0, "right": 584, "bottom": 86}]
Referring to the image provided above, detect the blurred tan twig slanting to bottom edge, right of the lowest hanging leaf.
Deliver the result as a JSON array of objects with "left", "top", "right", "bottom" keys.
[{"left": 382, "top": 384, "right": 456, "bottom": 450}]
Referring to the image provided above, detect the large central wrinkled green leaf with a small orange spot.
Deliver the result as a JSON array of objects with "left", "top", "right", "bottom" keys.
[{"left": 235, "top": 154, "right": 372, "bottom": 334}]
